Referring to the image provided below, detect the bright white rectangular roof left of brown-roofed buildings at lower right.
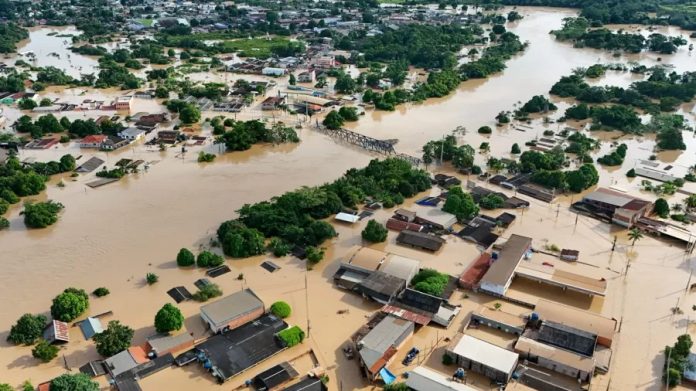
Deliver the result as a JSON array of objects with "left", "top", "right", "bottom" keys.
[{"left": 448, "top": 334, "right": 519, "bottom": 374}]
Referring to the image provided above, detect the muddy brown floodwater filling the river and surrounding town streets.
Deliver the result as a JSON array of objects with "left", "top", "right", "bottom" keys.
[{"left": 0, "top": 8, "right": 696, "bottom": 391}]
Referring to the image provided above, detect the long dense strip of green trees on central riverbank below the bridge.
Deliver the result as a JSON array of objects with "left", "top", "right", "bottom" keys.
[{"left": 217, "top": 159, "right": 430, "bottom": 257}]
